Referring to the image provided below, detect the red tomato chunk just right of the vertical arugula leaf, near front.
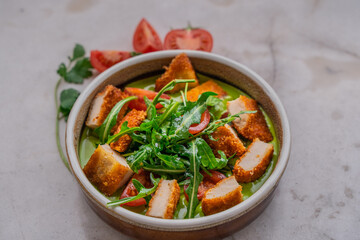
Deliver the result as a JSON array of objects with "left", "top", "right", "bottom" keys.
[{"left": 184, "top": 170, "right": 226, "bottom": 201}]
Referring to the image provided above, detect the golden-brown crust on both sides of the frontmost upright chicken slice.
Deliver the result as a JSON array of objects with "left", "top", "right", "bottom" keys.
[{"left": 146, "top": 179, "right": 180, "bottom": 219}]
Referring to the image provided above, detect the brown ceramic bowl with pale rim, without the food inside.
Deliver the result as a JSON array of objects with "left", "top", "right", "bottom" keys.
[{"left": 66, "top": 50, "right": 290, "bottom": 240}]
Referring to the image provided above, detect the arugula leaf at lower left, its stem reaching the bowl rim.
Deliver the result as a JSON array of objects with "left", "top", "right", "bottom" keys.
[{"left": 106, "top": 173, "right": 161, "bottom": 207}]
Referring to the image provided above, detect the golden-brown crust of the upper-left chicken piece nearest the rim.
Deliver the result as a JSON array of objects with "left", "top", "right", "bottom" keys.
[{"left": 88, "top": 85, "right": 128, "bottom": 129}]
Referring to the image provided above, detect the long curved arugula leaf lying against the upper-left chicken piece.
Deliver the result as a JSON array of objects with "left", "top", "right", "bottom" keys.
[{"left": 94, "top": 96, "right": 137, "bottom": 143}]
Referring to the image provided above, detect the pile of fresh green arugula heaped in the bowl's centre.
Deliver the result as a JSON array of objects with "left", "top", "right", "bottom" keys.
[{"left": 100, "top": 79, "right": 255, "bottom": 218}]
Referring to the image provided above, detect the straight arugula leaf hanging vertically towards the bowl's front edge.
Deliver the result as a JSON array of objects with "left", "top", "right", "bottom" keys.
[{"left": 186, "top": 140, "right": 203, "bottom": 218}]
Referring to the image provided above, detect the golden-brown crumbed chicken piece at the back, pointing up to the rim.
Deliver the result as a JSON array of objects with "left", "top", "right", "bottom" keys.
[{"left": 155, "top": 53, "right": 199, "bottom": 93}]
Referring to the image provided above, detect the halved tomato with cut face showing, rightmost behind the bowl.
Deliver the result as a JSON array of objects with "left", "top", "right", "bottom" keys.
[{"left": 164, "top": 27, "right": 213, "bottom": 52}]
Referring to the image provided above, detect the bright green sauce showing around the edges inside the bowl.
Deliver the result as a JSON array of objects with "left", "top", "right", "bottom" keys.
[{"left": 79, "top": 71, "right": 279, "bottom": 219}]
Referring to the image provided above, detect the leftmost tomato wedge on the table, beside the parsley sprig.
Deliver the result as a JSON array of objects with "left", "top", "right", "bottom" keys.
[{"left": 90, "top": 50, "right": 131, "bottom": 72}]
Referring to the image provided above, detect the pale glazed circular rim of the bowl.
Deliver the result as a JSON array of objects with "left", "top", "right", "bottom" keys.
[{"left": 65, "top": 50, "right": 291, "bottom": 231}]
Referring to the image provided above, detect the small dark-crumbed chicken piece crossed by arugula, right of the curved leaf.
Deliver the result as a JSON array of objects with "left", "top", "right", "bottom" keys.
[{"left": 110, "top": 109, "right": 146, "bottom": 152}]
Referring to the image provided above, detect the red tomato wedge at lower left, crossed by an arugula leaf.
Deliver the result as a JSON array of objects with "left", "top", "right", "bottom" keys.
[{"left": 120, "top": 169, "right": 152, "bottom": 207}]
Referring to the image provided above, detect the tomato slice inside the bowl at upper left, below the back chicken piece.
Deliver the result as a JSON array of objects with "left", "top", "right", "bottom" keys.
[{"left": 125, "top": 87, "right": 170, "bottom": 111}]
